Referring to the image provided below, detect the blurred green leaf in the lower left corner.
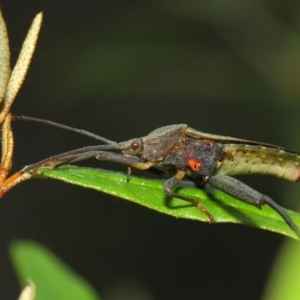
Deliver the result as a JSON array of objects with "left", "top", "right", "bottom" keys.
[{"left": 10, "top": 241, "right": 100, "bottom": 300}]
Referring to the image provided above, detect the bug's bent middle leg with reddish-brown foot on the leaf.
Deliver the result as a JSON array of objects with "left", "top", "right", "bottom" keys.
[{"left": 164, "top": 170, "right": 215, "bottom": 223}]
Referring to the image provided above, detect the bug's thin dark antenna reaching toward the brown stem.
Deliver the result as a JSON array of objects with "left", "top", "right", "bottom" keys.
[{"left": 11, "top": 116, "right": 116, "bottom": 144}]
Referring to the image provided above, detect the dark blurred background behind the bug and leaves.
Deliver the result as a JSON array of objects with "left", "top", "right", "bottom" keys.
[{"left": 0, "top": 0, "right": 300, "bottom": 300}]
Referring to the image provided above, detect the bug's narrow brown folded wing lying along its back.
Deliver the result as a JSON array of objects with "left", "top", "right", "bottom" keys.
[{"left": 185, "top": 127, "right": 284, "bottom": 152}]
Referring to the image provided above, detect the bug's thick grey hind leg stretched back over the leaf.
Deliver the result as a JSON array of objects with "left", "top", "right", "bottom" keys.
[{"left": 206, "top": 175, "right": 300, "bottom": 238}]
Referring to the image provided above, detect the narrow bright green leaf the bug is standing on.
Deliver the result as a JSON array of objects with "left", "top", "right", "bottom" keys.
[{"left": 35, "top": 166, "right": 300, "bottom": 239}]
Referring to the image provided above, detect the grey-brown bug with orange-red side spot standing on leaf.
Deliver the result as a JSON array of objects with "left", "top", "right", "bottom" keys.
[{"left": 7, "top": 116, "right": 300, "bottom": 238}]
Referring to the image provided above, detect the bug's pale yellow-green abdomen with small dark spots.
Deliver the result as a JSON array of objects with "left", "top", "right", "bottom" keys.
[{"left": 216, "top": 144, "right": 300, "bottom": 181}]
